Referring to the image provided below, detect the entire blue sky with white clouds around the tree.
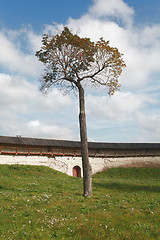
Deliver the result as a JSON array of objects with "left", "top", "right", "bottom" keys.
[{"left": 0, "top": 0, "right": 160, "bottom": 142}]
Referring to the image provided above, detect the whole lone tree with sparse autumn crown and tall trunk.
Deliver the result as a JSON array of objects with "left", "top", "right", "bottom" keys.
[{"left": 36, "top": 27, "right": 125, "bottom": 196}]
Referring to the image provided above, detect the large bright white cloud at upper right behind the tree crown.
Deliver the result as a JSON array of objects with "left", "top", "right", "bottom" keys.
[{"left": 68, "top": 0, "right": 160, "bottom": 89}]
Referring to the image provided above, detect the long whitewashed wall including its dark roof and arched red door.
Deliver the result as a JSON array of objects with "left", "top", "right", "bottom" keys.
[{"left": 0, "top": 136, "right": 160, "bottom": 177}]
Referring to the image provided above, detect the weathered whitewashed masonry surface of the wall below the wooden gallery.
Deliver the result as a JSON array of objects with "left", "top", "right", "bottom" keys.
[{"left": 0, "top": 154, "right": 160, "bottom": 176}]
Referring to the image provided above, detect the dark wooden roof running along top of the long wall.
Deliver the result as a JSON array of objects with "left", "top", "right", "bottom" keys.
[{"left": 0, "top": 136, "right": 160, "bottom": 150}]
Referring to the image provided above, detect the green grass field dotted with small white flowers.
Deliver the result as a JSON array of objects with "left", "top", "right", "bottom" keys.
[{"left": 0, "top": 165, "right": 160, "bottom": 240}]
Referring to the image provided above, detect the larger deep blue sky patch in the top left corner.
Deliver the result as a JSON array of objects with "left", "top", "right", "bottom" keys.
[{"left": 0, "top": 0, "right": 92, "bottom": 31}]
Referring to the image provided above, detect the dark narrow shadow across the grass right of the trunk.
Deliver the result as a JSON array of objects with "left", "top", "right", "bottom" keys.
[{"left": 93, "top": 182, "right": 160, "bottom": 193}]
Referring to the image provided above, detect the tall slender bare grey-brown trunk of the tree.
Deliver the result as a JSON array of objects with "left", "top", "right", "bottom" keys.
[{"left": 78, "top": 84, "right": 92, "bottom": 196}]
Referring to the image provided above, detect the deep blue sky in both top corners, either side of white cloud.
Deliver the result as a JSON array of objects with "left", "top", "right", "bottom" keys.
[{"left": 0, "top": 0, "right": 160, "bottom": 31}]
